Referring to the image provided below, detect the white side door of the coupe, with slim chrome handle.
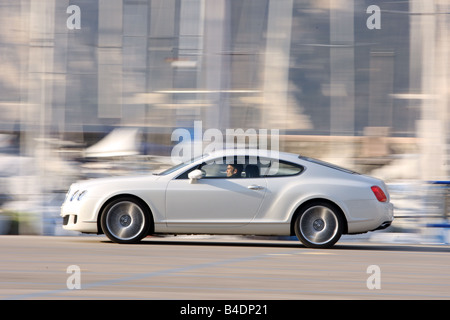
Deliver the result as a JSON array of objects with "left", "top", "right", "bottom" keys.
[{"left": 166, "top": 161, "right": 267, "bottom": 233}]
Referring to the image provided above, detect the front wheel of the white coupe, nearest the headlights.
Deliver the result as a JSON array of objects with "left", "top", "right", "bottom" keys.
[{"left": 101, "top": 197, "right": 152, "bottom": 243}]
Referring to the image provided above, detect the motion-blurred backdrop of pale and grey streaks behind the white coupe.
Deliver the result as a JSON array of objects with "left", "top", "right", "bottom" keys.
[{"left": 0, "top": 0, "right": 450, "bottom": 243}]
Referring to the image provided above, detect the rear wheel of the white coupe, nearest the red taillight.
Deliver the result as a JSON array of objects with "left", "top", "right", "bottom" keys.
[{"left": 294, "top": 202, "right": 344, "bottom": 248}]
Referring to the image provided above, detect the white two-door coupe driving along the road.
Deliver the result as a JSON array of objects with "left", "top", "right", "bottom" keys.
[{"left": 61, "top": 149, "right": 394, "bottom": 248}]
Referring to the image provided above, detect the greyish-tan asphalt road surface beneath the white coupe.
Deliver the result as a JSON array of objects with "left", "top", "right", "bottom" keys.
[{"left": 0, "top": 236, "right": 450, "bottom": 300}]
